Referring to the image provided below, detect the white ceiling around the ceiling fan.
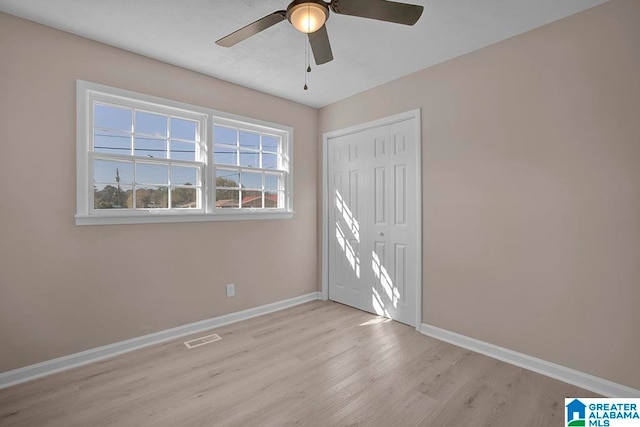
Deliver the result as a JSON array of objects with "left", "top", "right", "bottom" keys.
[{"left": 0, "top": 0, "right": 608, "bottom": 107}]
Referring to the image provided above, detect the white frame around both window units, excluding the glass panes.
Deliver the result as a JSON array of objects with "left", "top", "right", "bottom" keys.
[{"left": 75, "top": 80, "right": 293, "bottom": 225}]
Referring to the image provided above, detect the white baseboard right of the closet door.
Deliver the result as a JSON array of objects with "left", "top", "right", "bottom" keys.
[{"left": 420, "top": 323, "right": 640, "bottom": 398}]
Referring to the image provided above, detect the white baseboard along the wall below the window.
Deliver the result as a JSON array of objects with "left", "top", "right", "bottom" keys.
[{"left": 0, "top": 292, "right": 322, "bottom": 389}]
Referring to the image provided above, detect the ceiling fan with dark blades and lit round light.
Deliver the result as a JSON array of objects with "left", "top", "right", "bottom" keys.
[{"left": 216, "top": 0, "right": 424, "bottom": 65}]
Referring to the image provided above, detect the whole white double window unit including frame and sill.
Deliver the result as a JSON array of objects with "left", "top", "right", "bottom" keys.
[{"left": 76, "top": 81, "right": 293, "bottom": 225}]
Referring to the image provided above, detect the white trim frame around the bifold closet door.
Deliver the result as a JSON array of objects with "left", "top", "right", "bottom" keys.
[{"left": 322, "top": 108, "right": 422, "bottom": 331}]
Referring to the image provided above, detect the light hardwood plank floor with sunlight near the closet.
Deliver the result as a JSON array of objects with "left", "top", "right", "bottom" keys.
[{"left": 0, "top": 301, "right": 596, "bottom": 427}]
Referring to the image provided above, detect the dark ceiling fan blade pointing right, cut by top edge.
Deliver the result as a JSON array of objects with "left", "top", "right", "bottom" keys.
[{"left": 331, "top": 0, "right": 424, "bottom": 25}]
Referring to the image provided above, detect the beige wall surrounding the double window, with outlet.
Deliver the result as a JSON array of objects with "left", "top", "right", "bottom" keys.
[{"left": 0, "top": 14, "right": 317, "bottom": 372}]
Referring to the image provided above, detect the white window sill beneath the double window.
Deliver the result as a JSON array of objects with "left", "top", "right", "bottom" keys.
[{"left": 75, "top": 211, "right": 293, "bottom": 225}]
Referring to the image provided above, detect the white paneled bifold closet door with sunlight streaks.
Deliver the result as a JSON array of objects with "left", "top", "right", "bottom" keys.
[{"left": 328, "top": 120, "right": 420, "bottom": 326}]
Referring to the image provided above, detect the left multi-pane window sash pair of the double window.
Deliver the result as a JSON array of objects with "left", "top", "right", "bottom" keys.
[{"left": 89, "top": 99, "right": 206, "bottom": 211}]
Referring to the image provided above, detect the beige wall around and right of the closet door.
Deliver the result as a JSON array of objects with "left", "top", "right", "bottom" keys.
[{"left": 318, "top": 0, "right": 640, "bottom": 388}]
